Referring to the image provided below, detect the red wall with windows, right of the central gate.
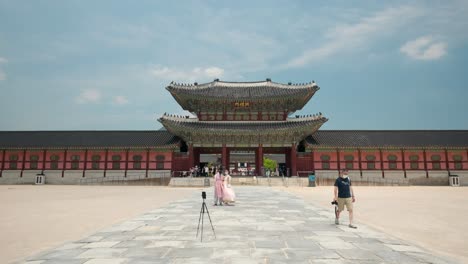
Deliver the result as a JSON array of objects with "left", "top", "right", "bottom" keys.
[{"left": 297, "top": 149, "right": 468, "bottom": 186}]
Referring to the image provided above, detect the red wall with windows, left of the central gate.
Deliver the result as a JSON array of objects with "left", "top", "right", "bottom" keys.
[{"left": 0, "top": 149, "right": 177, "bottom": 184}]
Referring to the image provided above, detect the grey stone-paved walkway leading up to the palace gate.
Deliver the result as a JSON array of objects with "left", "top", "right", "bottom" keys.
[{"left": 22, "top": 187, "right": 454, "bottom": 264}]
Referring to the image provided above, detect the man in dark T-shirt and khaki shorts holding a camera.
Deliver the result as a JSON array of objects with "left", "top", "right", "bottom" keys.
[{"left": 334, "top": 170, "right": 357, "bottom": 228}]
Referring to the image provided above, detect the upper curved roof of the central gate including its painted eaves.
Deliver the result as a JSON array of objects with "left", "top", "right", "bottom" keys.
[{"left": 166, "top": 79, "right": 320, "bottom": 113}]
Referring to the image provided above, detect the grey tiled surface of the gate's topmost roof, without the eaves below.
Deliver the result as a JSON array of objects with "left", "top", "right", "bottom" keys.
[{"left": 166, "top": 80, "right": 320, "bottom": 100}]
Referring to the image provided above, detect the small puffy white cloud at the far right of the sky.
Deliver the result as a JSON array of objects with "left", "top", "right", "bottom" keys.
[{"left": 400, "top": 36, "right": 447, "bottom": 60}]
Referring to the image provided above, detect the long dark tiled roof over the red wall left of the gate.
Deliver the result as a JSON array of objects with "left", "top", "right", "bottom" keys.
[{"left": 0, "top": 130, "right": 180, "bottom": 148}]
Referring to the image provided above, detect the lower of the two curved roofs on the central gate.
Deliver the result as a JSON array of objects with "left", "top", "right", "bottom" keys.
[{"left": 159, "top": 115, "right": 328, "bottom": 147}]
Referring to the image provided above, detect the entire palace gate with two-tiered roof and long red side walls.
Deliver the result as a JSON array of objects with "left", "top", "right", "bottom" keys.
[{"left": 0, "top": 79, "right": 468, "bottom": 185}]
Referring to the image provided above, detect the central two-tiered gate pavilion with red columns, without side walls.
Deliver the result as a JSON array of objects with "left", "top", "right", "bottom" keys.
[{"left": 159, "top": 79, "right": 328, "bottom": 176}]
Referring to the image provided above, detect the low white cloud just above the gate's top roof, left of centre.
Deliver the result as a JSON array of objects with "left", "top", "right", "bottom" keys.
[{"left": 149, "top": 65, "right": 224, "bottom": 82}]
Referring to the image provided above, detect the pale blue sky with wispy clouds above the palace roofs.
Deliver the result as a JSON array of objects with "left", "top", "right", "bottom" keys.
[{"left": 0, "top": 0, "right": 468, "bottom": 130}]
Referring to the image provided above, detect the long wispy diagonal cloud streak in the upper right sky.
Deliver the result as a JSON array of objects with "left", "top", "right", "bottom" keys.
[{"left": 283, "top": 6, "right": 420, "bottom": 68}]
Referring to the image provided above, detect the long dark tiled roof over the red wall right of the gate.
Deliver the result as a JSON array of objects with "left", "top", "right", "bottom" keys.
[{"left": 306, "top": 130, "right": 468, "bottom": 148}]
